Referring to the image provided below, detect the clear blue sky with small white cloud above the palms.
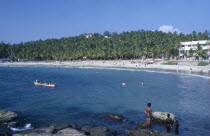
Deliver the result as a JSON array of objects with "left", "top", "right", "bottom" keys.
[{"left": 0, "top": 0, "right": 210, "bottom": 43}]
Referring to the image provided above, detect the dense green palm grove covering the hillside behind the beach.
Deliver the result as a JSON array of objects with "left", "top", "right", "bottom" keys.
[{"left": 0, "top": 30, "right": 210, "bottom": 60}]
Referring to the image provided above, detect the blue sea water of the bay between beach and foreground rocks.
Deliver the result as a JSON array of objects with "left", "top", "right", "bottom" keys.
[{"left": 0, "top": 66, "right": 210, "bottom": 136}]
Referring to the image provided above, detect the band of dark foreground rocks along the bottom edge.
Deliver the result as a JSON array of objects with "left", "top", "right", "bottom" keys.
[{"left": 11, "top": 123, "right": 174, "bottom": 136}]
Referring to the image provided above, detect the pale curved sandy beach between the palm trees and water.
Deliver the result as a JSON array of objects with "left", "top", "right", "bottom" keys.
[{"left": 0, "top": 60, "right": 210, "bottom": 77}]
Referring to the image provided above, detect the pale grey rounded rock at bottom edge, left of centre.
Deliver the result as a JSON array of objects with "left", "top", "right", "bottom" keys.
[{"left": 57, "top": 128, "right": 86, "bottom": 136}]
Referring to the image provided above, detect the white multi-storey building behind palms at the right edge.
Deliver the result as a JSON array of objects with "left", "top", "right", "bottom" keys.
[{"left": 179, "top": 40, "right": 210, "bottom": 57}]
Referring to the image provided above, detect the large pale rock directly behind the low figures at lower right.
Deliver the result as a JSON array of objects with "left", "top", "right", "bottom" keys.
[{"left": 152, "top": 112, "right": 175, "bottom": 122}]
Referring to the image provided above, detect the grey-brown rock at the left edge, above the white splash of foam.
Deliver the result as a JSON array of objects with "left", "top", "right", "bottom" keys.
[{"left": 0, "top": 110, "right": 17, "bottom": 122}]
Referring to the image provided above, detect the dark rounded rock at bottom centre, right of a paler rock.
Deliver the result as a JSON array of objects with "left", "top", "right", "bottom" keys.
[{"left": 90, "top": 127, "right": 116, "bottom": 136}]
